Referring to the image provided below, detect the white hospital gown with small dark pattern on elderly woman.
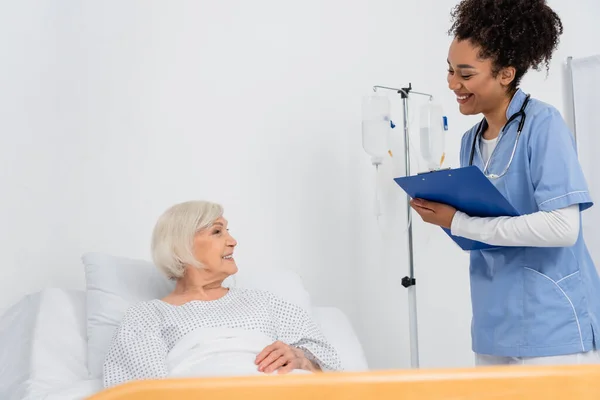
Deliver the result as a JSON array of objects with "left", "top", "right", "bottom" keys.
[{"left": 104, "top": 288, "right": 341, "bottom": 387}]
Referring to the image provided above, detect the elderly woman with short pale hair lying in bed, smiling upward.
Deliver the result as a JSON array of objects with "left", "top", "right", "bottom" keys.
[{"left": 104, "top": 201, "right": 341, "bottom": 387}]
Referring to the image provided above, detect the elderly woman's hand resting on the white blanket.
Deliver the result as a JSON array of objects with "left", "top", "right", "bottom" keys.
[{"left": 255, "top": 341, "right": 320, "bottom": 374}]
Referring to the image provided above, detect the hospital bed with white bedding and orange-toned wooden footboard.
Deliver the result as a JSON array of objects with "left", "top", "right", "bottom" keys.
[{"left": 0, "top": 256, "right": 600, "bottom": 400}]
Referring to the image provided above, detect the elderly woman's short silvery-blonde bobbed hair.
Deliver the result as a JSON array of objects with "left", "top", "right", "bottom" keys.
[{"left": 152, "top": 200, "right": 223, "bottom": 279}]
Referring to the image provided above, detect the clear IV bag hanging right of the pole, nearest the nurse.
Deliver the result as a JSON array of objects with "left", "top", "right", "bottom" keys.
[{"left": 420, "top": 101, "right": 446, "bottom": 170}]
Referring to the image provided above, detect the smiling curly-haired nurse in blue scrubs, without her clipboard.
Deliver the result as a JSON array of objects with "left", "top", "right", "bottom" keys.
[{"left": 411, "top": 0, "right": 600, "bottom": 365}]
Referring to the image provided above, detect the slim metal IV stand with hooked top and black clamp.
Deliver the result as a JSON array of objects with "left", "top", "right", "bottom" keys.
[{"left": 373, "top": 83, "right": 433, "bottom": 368}]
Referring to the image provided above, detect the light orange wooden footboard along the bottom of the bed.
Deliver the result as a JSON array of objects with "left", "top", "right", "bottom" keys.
[{"left": 90, "top": 365, "right": 600, "bottom": 400}]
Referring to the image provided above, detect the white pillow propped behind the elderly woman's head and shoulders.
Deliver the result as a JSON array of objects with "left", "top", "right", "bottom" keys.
[{"left": 82, "top": 253, "right": 311, "bottom": 378}]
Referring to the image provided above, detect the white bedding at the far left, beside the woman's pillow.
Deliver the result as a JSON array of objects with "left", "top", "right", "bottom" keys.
[{"left": 0, "top": 288, "right": 88, "bottom": 400}]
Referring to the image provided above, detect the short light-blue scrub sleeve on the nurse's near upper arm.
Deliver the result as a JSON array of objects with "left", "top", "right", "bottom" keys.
[{"left": 528, "top": 109, "right": 593, "bottom": 211}]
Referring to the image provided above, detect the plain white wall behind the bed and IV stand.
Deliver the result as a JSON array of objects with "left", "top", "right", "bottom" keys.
[{"left": 0, "top": 0, "right": 600, "bottom": 368}]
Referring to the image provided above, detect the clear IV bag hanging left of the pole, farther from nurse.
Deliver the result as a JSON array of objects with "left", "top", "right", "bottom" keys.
[{"left": 362, "top": 95, "right": 391, "bottom": 164}]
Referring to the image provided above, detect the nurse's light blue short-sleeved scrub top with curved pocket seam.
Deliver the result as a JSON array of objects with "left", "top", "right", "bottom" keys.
[{"left": 460, "top": 90, "right": 600, "bottom": 357}]
